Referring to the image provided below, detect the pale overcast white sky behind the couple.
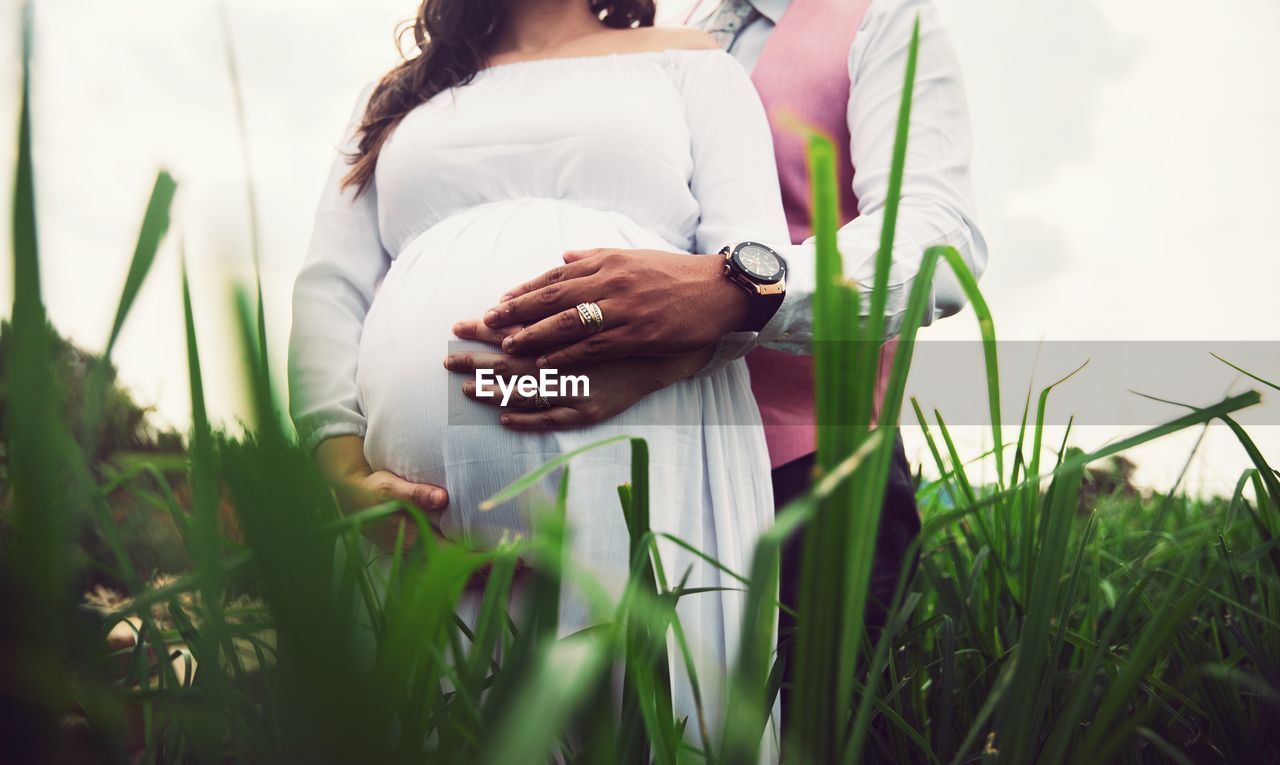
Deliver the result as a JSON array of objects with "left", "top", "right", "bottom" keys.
[{"left": 0, "top": 0, "right": 1280, "bottom": 491}]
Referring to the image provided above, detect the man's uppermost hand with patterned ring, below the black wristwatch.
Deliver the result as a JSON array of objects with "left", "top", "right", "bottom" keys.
[{"left": 484, "top": 249, "right": 750, "bottom": 368}]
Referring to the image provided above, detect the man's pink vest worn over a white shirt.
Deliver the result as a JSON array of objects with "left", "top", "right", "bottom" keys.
[{"left": 746, "top": 0, "right": 896, "bottom": 467}]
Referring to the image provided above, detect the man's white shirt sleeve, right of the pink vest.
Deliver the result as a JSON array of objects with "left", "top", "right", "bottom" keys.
[{"left": 758, "top": 0, "right": 987, "bottom": 353}]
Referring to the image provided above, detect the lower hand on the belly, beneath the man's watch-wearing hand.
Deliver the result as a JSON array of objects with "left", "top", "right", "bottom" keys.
[{"left": 444, "top": 321, "right": 712, "bottom": 431}]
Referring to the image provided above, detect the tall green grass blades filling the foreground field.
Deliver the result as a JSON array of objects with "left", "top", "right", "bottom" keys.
[{"left": 0, "top": 10, "right": 1280, "bottom": 764}]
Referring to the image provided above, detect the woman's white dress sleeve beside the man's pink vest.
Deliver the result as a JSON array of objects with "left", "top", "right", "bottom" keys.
[{"left": 682, "top": 51, "right": 791, "bottom": 375}]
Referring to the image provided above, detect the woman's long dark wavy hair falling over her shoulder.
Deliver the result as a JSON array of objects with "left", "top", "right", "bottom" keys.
[{"left": 342, "top": 0, "right": 654, "bottom": 194}]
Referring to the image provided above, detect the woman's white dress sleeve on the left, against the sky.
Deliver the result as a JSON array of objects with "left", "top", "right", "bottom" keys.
[{"left": 289, "top": 86, "right": 390, "bottom": 450}]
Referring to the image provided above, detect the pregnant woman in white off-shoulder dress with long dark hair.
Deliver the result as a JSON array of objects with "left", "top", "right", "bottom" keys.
[{"left": 289, "top": 0, "right": 787, "bottom": 729}]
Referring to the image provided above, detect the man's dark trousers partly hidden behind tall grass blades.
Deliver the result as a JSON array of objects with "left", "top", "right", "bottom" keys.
[{"left": 773, "top": 439, "right": 920, "bottom": 729}]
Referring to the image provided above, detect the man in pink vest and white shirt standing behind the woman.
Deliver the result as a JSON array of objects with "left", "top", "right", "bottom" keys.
[{"left": 414, "top": 0, "right": 987, "bottom": 726}]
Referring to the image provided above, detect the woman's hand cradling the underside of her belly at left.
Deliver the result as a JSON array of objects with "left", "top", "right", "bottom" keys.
[{"left": 316, "top": 436, "right": 449, "bottom": 550}]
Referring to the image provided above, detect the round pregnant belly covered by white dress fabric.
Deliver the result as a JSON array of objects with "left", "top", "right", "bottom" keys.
[{"left": 357, "top": 200, "right": 673, "bottom": 544}]
